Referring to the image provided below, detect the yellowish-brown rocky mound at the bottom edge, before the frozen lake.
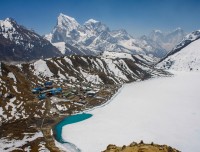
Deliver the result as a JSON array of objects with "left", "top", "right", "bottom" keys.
[{"left": 103, "top": 141, "right": 180, "bottom": 152}]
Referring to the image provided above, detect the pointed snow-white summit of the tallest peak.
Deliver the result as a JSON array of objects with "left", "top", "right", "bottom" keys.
[{"left": 57, "top": 13, "right": 79, "bottom": 31}]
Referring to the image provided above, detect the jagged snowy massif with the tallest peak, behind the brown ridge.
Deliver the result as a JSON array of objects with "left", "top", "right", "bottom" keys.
[{"left": 45, "top": 13, "right": 170, "bottom": 57}]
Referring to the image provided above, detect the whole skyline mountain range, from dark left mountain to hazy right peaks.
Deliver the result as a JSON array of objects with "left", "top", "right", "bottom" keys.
[{"left": 0, "top": 13, "right": 187, "bottom": 61}]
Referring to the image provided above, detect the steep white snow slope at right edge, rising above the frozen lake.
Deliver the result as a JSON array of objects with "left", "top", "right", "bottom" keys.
[{"left": 157, "top": 30, "right": 200, "bottom": 71}]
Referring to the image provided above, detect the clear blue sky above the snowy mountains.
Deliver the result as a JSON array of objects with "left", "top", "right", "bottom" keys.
[{"left": 0, "top": 0, "right": 200, "bottom": 36}]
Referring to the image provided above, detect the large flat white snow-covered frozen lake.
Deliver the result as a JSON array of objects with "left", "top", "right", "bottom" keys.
[{"left": 62, "top": 72, "right": 200, "bottom": 152}]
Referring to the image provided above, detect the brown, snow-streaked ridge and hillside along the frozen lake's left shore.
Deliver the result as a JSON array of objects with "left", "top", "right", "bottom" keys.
[{"left": 0, "top": 52, "right": 170, "bottom": 151}]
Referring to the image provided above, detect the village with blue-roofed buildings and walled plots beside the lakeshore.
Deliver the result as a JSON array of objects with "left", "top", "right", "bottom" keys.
[{"left": 31, "top": 81, "right": 118, "bottom": 115}]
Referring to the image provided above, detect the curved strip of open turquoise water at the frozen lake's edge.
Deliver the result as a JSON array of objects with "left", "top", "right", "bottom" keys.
[{"left": 54, "top": 113, "right": 92, "bottom": 143}]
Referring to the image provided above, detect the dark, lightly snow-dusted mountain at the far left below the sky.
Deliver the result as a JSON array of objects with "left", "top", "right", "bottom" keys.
[{"left": 0, "top": 18, "right": 61, "bottom": 61}]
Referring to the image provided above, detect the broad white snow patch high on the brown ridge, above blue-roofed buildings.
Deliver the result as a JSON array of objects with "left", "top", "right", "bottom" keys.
[{"left": 34, "top": 60, "right": 53, "bottom": 77}]
